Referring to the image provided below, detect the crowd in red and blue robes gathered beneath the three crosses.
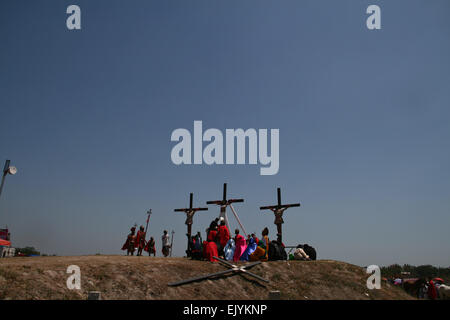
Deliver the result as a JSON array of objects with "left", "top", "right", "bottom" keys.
[{"left": 187, "top": 218, "right": 286, "bottom": 262}]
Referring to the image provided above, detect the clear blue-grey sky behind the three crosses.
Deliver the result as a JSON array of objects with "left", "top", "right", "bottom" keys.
[{"left": 0, "top": 0, "right": 450, "bottom": 266}]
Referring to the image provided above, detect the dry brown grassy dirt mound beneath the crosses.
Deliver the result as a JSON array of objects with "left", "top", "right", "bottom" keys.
[{"left": 0, "top": 256, "right": 412, "bottom": 300}]
